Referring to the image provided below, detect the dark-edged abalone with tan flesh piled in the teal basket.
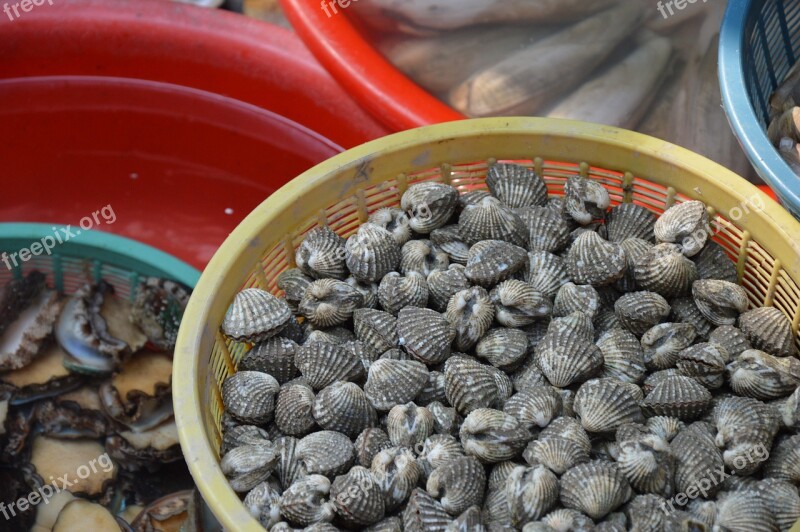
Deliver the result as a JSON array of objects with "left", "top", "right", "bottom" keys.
[{"left": 0, "top": 270, "right": 193, "bottom": 532}]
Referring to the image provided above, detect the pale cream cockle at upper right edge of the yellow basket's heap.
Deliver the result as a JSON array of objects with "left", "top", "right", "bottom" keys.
[{"left": 653, "top": 201, "right": 710, "bottom": 257}]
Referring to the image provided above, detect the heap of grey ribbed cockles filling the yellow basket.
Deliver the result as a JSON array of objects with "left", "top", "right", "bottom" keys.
[{"left": 220, "top": 164, "right": 800, "bottom": 532}]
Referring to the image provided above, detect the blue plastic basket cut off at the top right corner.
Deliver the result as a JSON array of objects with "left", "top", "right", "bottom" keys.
[{"left": 719, "top": 0, "right": 800, "bottom": 218}]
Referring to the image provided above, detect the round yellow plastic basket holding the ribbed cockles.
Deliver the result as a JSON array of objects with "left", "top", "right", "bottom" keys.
[{"left": 173, "top": 118, "right": 800, "bottom": 531}]
